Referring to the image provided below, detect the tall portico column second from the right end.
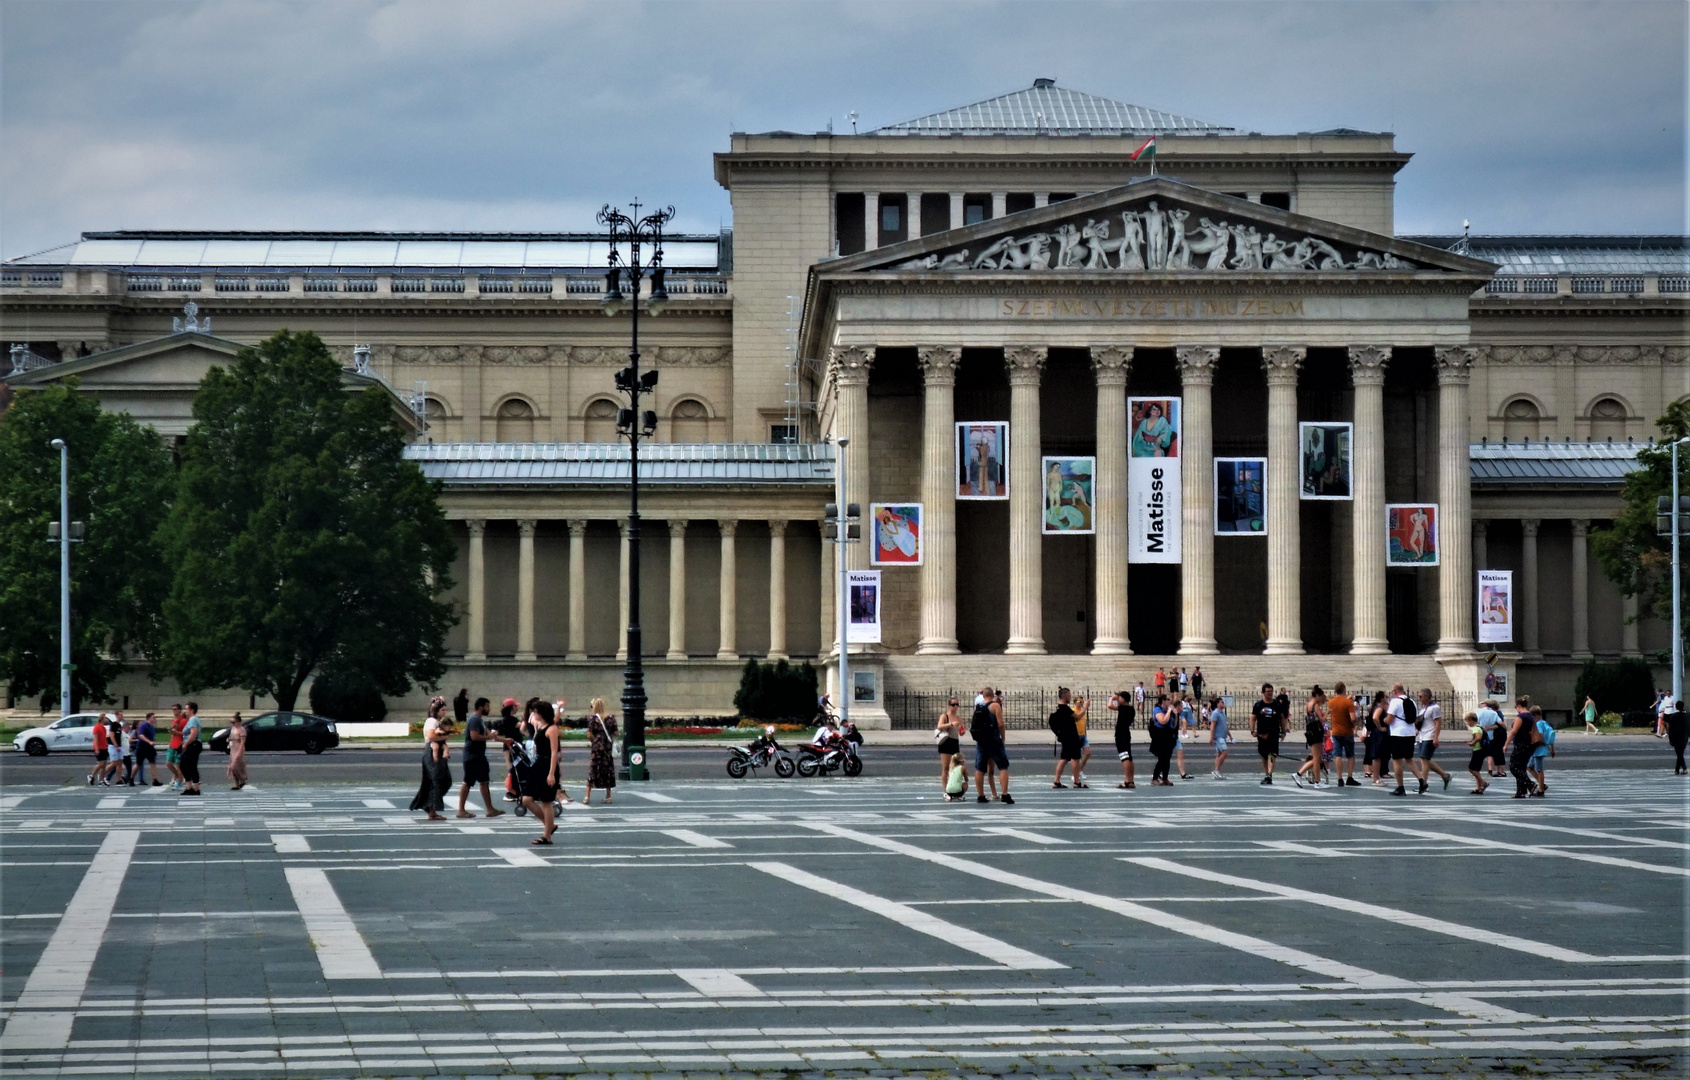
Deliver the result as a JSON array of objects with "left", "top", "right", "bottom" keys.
[{"left": 1350, "top": 345, "right": 1391, "bottom": 656}]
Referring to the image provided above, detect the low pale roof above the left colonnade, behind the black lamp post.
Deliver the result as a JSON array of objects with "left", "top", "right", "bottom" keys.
[{"left": 406, "top": 443, "right": 833, "bottom": 487}]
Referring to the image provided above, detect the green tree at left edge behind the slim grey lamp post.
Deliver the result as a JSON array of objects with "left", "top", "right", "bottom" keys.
[{"left": 0, "top": 379, "right": 174, "bottom": 708}]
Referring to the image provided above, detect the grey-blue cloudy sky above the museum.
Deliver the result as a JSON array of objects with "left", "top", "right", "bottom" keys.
[{"left": 0, "top": 0, "right": 1690, "bottom": 257}]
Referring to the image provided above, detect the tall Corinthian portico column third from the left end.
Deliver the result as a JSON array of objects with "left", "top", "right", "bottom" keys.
[{"left": 1004, "top": 345, "right": 1049, "bottom": 652}]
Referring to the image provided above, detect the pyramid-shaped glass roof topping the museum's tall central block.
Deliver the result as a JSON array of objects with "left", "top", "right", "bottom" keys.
[{"left": 867, "top": 79, "right": 1235, "bottom": 135}]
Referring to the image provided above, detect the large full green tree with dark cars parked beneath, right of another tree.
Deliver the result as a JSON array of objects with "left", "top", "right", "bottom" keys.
[{"left": 162, "top": 330, "right": 453, "bottom": 710}]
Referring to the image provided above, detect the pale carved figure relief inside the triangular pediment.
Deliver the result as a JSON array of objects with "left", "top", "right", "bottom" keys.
[{"left": 892, "top": 199, "right": 1420, "bottom": 272}]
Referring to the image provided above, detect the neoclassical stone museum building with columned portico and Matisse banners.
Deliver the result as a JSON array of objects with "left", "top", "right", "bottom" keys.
[{"left": 0, "top": 79, "right": 1690, "bottom": 723}]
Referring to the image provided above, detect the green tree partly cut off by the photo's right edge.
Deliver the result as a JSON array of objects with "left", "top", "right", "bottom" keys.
[{"left": 1590, "top": 401, "right": 1690, "bottom": 645}]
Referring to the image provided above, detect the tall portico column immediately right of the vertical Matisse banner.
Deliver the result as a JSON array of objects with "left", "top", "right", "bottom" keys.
[{"left": 1176, "top": 345, "right": 1220, "bottom": 656}]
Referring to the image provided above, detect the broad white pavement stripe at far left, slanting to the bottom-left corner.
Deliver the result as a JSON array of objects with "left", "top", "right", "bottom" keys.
[{"left": 0, "top": 830, "right": 140, "bottom": 1050}]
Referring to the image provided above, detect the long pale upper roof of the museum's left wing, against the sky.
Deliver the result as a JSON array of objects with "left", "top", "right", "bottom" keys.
[{"left": 5, "top": 230, "right": 730, "bottom": 272}]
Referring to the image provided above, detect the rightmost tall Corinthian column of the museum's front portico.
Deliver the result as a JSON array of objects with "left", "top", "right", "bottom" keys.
[{"left": 1437, "top": 345, "right": 1474, "bottom": 656}]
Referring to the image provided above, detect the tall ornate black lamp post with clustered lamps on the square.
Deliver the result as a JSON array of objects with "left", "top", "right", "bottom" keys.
[{"left": 598, "top": 201, "right": 674, "bottom": 777}]
